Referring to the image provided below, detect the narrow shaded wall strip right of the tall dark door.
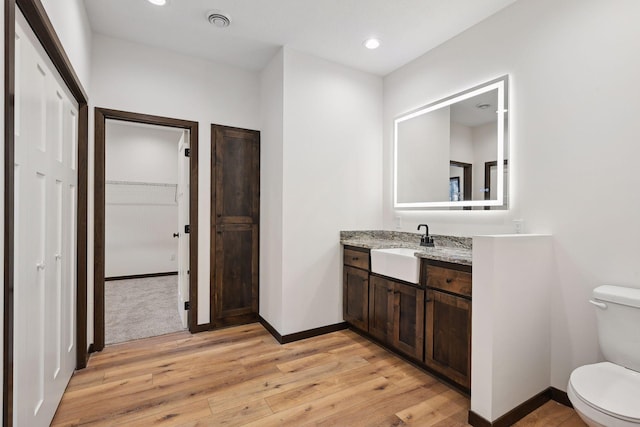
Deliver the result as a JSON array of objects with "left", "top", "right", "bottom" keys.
[{"left": 260, "top": 49, "right": 284, "bottom": 331}]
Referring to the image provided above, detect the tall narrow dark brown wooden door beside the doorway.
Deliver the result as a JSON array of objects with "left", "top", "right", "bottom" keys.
[{"left": 211, "top": 125, "right": 260, "bottom": 326}]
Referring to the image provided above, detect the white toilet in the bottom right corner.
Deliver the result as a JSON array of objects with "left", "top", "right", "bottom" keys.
[{"left": 567, "top": 285, "right": 640, "bottom": 427}]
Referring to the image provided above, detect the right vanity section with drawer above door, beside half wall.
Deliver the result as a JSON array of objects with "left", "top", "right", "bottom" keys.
[{"left": 424, "top": 262, "right": 471, "bottom": 389}]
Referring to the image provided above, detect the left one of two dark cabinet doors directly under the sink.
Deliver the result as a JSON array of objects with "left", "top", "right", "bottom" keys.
[{"left": 369, "top": 275, "right": 393, "bottom": 342}]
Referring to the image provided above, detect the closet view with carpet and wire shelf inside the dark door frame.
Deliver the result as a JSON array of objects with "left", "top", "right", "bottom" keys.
[{"left": 105, "top": 119, "right": 189, "bottom": 345}]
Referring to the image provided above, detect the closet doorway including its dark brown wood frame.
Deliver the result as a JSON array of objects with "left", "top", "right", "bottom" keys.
[{"left": 94, "top": 108, "right": 198, "bottom": 351}]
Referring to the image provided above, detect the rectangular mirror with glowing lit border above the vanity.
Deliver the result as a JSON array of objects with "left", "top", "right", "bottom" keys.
[{"left": 393, "top": 76, "right": 509, "bottom": 210}]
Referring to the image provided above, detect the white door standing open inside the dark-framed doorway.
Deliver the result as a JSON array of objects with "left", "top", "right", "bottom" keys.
[{"left": 177, "top": 130, "right": 189, "bottom": 328}]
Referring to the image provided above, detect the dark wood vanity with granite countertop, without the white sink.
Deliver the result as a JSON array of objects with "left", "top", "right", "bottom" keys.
[{"left": 341, "top": 231, "right": 471, "bottom": 392}]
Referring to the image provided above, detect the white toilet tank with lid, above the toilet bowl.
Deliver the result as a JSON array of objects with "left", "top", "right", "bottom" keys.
[{"left": 593, "top": 285, "right": 640, "bottom": 372}]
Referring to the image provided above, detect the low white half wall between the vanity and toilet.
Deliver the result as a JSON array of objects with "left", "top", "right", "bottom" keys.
[{"left": 471, "top": 234, "right": 553, "bottom": 421}]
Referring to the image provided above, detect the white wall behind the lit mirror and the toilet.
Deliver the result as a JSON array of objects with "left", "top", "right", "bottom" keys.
[{"left": 384, "top": 0, "right": 640, "bottom": 396}]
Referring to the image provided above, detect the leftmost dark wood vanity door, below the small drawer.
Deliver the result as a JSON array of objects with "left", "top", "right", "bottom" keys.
[{"left": 342, "top": 266, "right": 369, "bottom": 331}]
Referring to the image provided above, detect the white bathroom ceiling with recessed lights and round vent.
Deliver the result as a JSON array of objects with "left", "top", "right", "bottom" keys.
[{"left": 84, "top": 0, "right": 516, "bottom": 75}]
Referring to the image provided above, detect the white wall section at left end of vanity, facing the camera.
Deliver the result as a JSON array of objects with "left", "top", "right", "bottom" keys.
[{"left": 278, "top": 48, "right": 382, "bottom": 335}]
